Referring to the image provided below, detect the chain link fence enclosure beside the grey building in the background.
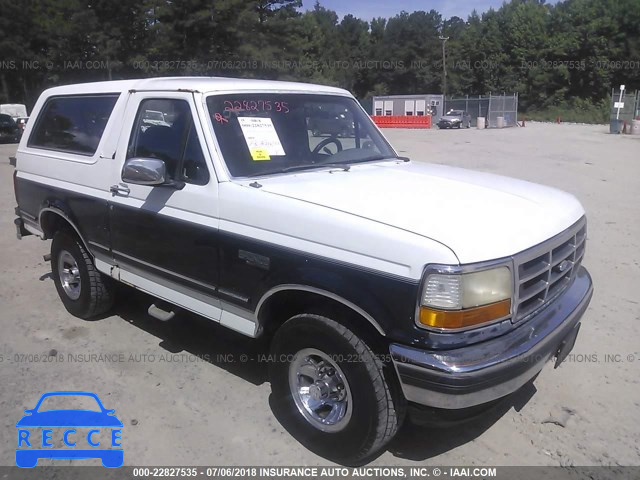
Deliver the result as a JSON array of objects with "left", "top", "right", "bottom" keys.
[{"left": 445, "top": 93, "right": 518, "bottom": 128}]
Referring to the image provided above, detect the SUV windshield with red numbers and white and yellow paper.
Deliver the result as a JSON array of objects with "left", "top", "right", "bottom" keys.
[{"left": 207, "top": 93, "right": 396, "bottom": 177}]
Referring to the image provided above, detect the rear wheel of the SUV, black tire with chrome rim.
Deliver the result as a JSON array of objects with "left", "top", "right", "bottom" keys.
[{"left": 51, "top": 230, "right": 114, "bottom": 319}]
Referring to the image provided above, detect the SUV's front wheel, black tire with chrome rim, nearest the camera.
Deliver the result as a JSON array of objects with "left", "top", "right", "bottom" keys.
[{"left": 269, "top": 314, "right": 405, "bottom": 465}]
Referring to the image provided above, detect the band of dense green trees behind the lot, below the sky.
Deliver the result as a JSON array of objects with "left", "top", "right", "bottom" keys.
[{"left": 0, "top": 0, "right": 640, "bottom": 112}]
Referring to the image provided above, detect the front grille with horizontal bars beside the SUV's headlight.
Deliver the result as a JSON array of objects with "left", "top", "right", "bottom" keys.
[{"left": 513, "top": 217, "right": 587, "bottom": 323}]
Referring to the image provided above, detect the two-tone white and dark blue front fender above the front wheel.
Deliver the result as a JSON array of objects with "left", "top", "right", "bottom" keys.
[{"left": 220, "top": 182, "right": 457, "bottom": 343}]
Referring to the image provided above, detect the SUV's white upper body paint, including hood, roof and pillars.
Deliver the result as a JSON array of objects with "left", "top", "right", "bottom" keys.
[{"left": 18, "top": 77, "right": 584, "bottom": 280}]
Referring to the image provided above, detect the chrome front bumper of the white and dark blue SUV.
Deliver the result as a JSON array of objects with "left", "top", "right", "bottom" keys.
[{"left": 389, "top": 267, "right": 593, "bottom": 409}]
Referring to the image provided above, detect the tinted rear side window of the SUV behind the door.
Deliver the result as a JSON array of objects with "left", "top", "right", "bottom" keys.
[{"left": 28, "top": 94, "right": 119, "bottom": 156}]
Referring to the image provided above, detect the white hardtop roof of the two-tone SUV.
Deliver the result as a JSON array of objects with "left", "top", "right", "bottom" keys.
[{"left": 45, "top": 77, "right": 351, "bottom": 95}]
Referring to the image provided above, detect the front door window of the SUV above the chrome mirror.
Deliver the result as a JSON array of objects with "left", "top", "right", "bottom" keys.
[{"left": 127, "top": 99, "right": 209, "bottom": 185}]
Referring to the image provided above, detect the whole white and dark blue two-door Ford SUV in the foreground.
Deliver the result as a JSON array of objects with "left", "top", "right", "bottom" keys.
[{"left": 15, "top": 77, "right": 593, "bottom": 464}]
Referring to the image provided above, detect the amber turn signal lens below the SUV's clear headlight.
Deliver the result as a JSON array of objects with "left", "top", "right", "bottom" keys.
[{"left": 420, "top": 300, "right": 511, "bottom": 329}]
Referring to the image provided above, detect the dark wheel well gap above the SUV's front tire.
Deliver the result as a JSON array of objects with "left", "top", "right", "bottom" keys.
[{"left": 258, "top": 290, "right": 386, "bottom": 351}]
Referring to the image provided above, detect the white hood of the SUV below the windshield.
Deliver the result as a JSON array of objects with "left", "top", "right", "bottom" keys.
[{"left": 249, "top": 162, "right": 584, "bottom": 264}]
